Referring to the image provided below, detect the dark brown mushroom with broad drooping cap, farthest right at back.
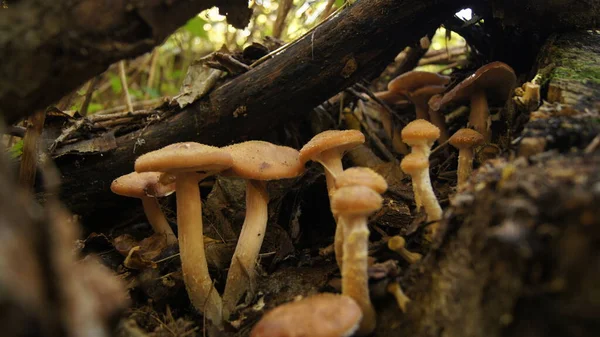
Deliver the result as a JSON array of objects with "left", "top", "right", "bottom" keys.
[{"left": 430, "top": 62, "right": 517, "bottom": 142}]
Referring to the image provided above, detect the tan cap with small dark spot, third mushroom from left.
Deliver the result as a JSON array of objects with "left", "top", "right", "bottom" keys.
[{"left": 223, "top": 140, "right": 304, "bottom": 180}]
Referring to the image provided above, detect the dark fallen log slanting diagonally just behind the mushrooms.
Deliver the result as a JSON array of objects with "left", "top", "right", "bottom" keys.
[{"left": 51, "top": 0, "right": 469, "bottom": 225}]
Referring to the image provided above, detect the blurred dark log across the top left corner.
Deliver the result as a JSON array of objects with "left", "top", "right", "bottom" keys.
[{"left": 0, "top": 0, "right": 251, "bottom": 124}]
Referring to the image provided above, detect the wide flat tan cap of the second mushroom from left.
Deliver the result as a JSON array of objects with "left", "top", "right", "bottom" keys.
[{"left": 135, "top": 142, "right": 233, "bottom": 172}]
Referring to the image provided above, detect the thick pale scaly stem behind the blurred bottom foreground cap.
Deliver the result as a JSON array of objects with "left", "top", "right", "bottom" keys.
[{"left": 338, "top": 215, "right": 376, "bottom": 336}]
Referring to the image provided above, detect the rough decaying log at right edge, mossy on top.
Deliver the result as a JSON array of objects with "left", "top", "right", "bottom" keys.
[{"left": 378, "top": 32, "right": 600, "bottom": 337}]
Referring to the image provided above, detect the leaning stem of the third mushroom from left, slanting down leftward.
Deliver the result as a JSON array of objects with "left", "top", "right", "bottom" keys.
[{"left": 223, "top": 180, "right": 269, "bottom": 319}]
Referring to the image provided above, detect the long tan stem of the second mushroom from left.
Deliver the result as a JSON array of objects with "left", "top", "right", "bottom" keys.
[{"left": 175, "top": 173, "right": 223, "bottom": 325}]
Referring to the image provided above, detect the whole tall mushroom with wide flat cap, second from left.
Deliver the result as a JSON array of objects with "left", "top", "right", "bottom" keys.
[{"left": 135, "top": 142, "right": 233, "bottom": 325}]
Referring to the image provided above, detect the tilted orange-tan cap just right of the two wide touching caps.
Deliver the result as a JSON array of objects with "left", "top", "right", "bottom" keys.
[{"left": 300, "top": 130, "right": 365, "bottom": 165}]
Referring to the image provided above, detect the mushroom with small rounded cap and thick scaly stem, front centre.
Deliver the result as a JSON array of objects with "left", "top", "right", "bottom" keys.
[{"left": 331, "top": 186, "right": 383, "bottom": 336}]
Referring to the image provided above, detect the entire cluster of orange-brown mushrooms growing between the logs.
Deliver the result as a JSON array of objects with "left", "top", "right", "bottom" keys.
[{"left": 111, "top": 62, "right": 516, "bottom": 337}]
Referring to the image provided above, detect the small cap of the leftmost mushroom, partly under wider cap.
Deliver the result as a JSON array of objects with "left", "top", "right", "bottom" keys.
[{"left": 110, "top": 172, "right": 175, "bottom": 198}]
